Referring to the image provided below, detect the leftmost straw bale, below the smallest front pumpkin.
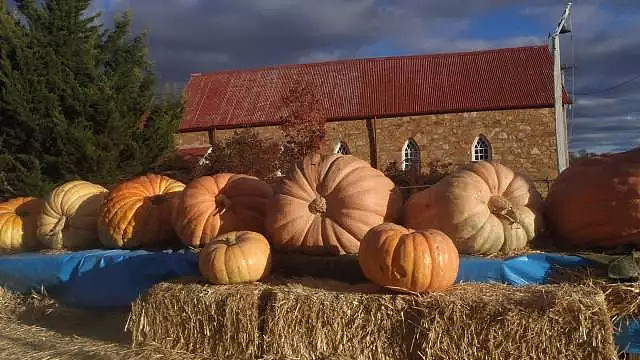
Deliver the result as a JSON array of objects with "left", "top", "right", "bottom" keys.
[{"left": 127, "top": 281, "right": 264, "bottom": 359}]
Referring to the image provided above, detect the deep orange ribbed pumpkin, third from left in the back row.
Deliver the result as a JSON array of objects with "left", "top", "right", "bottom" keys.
[{"left": 98, "top": 174, "right": 184, "bottom": 248}]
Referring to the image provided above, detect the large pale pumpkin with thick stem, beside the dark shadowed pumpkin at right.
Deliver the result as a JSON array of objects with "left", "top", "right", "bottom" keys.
[{"left": 404, "top": 161, "right": 543, "bottom": 255}]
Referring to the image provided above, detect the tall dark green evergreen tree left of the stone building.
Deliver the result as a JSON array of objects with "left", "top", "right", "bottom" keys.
[{"left": 0, "top": 0, "right": 182, "bottom": 196}]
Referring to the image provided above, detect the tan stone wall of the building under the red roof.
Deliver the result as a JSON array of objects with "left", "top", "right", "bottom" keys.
[{"left": 180, "top": 108, "right": 558, "bottom": 194}]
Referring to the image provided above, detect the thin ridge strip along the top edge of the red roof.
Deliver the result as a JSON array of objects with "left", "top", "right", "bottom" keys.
[{"left": 191, "top": 44, "right": 547, "bottom": 79}]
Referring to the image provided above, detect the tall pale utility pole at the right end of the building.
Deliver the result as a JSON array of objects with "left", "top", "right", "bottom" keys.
[{"left": 551, "top": 2, "right": 571, "bottom": 172}]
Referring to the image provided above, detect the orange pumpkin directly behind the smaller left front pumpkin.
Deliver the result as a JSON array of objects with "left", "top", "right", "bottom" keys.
[{"left": 173, "top": 173, "right": 273, "bottom": 247}]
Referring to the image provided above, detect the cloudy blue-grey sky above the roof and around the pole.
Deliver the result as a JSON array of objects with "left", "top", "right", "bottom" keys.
[{"left": 8, "top": 0, "right": 640, "bottom": 152}]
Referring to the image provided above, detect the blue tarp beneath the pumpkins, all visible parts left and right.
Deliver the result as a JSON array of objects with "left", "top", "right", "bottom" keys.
[{"left": 0, "top": 250, "right": 640, "bottom": 353}]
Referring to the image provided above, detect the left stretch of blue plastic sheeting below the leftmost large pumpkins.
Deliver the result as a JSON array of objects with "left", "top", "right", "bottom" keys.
[{"left": 0, "top": 250, "right": 199, "bottom": 307}]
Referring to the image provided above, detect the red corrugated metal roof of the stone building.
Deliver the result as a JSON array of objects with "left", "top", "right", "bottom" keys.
[{"left": 180, "top": 45, "right": 568, "bottom": 131}]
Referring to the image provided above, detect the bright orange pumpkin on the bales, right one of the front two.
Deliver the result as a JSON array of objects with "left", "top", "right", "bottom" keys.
[{"left": 358, "top": 223, "right": 460, "bottom": 293}]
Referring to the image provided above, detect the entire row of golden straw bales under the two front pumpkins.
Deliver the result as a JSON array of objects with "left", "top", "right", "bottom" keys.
[{"left": 129, "top": 278, "right": 616, "bottom": 360}]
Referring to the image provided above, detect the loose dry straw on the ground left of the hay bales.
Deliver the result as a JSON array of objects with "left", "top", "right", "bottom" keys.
[{"left": 0, "top": 287, "right": 206, "bottom": 360}]
